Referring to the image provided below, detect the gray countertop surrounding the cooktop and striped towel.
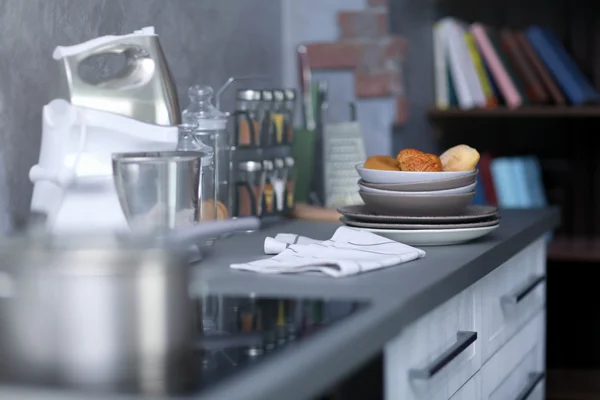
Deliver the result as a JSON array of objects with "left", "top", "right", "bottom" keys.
[{"left": 0, "top": 209, "right": 559, "bottom": 400}]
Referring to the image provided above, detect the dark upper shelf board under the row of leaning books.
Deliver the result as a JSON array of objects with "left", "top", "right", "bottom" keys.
[{"left": 427, "top": 106, "right": 600, "bottom": 119}]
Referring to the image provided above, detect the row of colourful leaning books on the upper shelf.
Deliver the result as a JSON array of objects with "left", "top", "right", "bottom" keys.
[{"left": 433, "top": 17, "right": 600, "bottom": 109}]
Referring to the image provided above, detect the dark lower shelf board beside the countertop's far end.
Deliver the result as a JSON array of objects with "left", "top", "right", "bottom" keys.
[{"left": 548, "top": 236, "right": 600, "bottom": 262}]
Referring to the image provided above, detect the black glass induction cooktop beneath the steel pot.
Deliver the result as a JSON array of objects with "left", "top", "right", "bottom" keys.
[{"left": 4, "top": 294, "right": 368, "bottom": 398}]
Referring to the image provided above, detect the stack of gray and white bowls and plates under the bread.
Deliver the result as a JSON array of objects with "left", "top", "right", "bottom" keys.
[{"left": 338, "top": 165, "right": 500, "bottom": 246}]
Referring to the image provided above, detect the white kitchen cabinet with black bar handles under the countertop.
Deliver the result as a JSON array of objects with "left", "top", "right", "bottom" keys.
[{"left": 384, "top": 238, "right": 546, "bottom": 400}]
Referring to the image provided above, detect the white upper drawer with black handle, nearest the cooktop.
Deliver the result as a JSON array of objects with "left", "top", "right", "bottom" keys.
[{"left": 385, "top": 287, "right": 481, "bottom": 400}]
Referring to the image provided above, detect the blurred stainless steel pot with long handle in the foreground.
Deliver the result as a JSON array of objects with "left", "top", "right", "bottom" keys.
[{"left": 0, "top": 218, "right": 259, "bottom": 395}]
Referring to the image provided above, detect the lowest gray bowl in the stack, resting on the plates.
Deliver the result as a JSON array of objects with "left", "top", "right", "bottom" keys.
[{"left": 358, "top": 190, "right": 475, "bottom": 217}]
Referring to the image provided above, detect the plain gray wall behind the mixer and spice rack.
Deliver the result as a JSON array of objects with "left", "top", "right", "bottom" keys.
[{"left": 0, "top": 0, "right": 281, "bottom": 223}]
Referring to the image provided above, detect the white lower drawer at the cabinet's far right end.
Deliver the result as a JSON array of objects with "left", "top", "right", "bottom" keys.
[{"left": 481, "top": 311, "right": 546, "bottom": 400}]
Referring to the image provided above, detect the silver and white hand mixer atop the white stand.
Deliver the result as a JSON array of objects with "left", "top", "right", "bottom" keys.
[{"left": 52, "top": 27, "right": 181, "bottom": 125}]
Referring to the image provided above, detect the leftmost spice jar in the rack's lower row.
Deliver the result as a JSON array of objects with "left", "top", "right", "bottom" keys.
[{"left": 235, "top": 161, "right": 265, "bottom": 217}]
